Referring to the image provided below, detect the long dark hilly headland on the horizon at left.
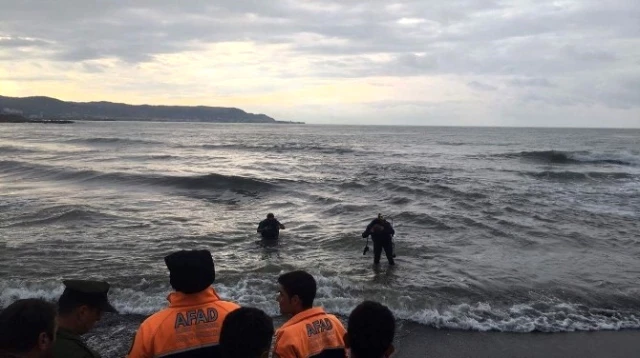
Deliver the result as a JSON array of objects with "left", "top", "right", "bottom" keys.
[{"left": 0, "top": 96, "right": 300, "bottom": 123}]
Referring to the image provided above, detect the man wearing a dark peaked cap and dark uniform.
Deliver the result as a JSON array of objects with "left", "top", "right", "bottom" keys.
[{"left": 53, "top": 280, "right": 116, "bottom": 358}]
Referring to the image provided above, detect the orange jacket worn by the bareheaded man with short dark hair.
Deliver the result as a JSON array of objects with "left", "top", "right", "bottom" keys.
[{"left": 273, "top": 307, "right": 347, "bottom": 358}]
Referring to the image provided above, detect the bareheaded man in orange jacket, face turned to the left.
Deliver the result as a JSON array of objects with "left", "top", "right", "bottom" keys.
[{"left": 273, "top": 271, "right": 346, "bottom": 358}]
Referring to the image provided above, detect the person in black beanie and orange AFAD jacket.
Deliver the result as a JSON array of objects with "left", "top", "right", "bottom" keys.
[{"left": 127, "top": 250, "right": 240, "bottom": 358}]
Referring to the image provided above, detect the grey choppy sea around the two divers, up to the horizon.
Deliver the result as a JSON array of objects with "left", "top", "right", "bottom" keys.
[{"left": 0, "top": 121, "right": 640, "bottom": 357}]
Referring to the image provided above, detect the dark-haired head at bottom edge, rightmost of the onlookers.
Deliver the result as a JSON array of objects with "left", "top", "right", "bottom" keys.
[{"left": 344, "top": 301, "right": 396, "bottom": 358}]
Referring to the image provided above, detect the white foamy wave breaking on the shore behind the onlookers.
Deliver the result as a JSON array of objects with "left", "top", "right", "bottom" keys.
[{"left": 0, "top": 277, "right": 640, "bottom": 332}]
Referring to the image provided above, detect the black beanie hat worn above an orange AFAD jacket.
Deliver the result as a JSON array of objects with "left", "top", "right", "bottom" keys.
[{"left": 164, "top": 250, "right": 216, "bottom": 294}]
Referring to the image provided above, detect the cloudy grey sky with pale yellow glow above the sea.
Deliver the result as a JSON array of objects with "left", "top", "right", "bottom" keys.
[{"left": 0, "top": 0, "right": 640, "bottom": 127}]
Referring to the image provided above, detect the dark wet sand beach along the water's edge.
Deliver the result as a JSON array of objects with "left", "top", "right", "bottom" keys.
[{"left": 85, "top": 314, "right": 640, "bottom": 358}]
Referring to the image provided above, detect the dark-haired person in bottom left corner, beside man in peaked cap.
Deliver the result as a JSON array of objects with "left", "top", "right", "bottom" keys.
[{"left": 0, "top": 298, "right": 56, "bottom": 358}]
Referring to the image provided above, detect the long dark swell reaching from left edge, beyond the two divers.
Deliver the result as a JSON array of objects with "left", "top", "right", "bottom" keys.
[{"left": 0, "top": 160, "right": 276, "bottom": 191}]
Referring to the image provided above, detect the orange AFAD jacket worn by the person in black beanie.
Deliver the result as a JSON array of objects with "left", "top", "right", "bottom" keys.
[{"left": 127, "top": 287, "right": 240, "bottom": 358}]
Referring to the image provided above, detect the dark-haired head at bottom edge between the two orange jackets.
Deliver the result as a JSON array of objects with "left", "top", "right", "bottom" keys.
[{"left": 220, "top": 307, "right": 274, "bottom": 358}]
